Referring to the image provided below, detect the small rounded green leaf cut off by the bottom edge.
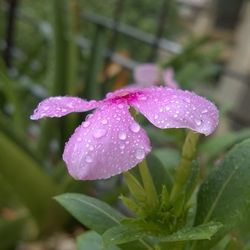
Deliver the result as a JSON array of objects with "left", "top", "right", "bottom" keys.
[{"left": 77, "top": 231, "right": 120, "bottom": 250}]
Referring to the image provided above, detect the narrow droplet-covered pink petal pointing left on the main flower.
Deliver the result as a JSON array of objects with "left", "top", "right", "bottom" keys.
[{"left": 30, "top": 96, "right": 98, "bottom": 120}]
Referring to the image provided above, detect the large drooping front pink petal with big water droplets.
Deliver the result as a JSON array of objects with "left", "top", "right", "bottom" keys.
[{"left": 63, "top": 103, "right": 150, "bottom": 180}]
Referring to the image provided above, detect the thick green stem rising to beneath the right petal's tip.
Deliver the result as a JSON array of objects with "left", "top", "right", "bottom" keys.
[{"left": 170, "top": 131, "right": 199, "bottom": 203}]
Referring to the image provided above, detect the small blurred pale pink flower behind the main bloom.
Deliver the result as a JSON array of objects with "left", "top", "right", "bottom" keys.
[{"left": 134, "top": 63, "right": 179, "bottom": 89}]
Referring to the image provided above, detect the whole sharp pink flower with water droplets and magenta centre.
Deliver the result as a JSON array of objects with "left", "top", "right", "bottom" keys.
[{"left": 31, "top": 87, "right": 218, "bottom": 180}]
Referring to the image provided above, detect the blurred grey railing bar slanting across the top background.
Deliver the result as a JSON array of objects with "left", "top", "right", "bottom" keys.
[{"left": 82, "top": 12, "right": 182, "bottom": 54}]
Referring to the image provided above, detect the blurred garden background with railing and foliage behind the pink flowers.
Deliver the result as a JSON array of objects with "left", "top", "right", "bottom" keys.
[{"left": 0, "top": 0, "right": 250, "bottom": 250}]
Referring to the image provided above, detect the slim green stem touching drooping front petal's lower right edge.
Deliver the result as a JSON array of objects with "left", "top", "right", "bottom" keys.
[{"left": 139, "top": 160, "right": 159, "bottom": 207}]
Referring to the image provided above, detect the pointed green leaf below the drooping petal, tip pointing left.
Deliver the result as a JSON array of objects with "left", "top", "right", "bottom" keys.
[{"left": 55, "top": 193, "right": 124, "bottom": 234}]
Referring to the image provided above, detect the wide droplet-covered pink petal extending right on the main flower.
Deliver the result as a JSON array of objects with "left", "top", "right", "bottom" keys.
[{"left": 131, "top": 87, "right": 219, "bottom": 135}]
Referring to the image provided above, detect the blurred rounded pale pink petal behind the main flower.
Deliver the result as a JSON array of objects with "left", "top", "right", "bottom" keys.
[{"left": 134, "top": 63, "right": 161, "bottom": 87}]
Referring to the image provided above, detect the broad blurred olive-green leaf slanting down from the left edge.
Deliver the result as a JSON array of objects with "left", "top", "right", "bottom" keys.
[{"left": 0, "top": 131, "right": 63, "bottom": 230}]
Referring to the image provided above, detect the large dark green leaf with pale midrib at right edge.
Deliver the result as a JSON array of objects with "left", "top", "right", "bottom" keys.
[{"left": 196, "top": 139, "right": 250, "bottom": 249}]
